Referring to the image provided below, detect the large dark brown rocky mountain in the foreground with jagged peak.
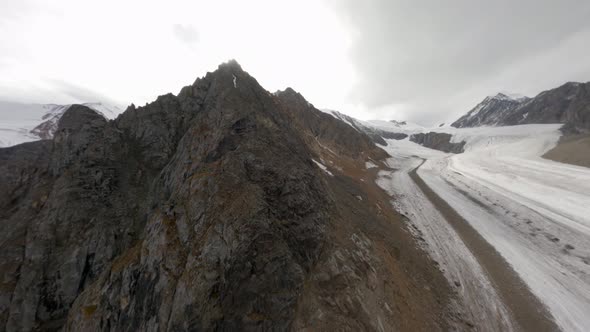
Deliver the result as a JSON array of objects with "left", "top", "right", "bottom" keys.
[{"left": 0, "top": 61, "right": 460, "bottom": 331}]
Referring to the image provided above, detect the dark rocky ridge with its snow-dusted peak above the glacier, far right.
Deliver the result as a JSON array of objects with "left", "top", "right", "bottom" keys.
[{"left": 452, "top": 82, "right": 590, "bottom": 133}]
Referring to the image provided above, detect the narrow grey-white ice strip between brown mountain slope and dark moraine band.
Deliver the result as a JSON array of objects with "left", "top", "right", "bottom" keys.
[{"left": 377, "top": 151, "right": 515, "bottom": 331}]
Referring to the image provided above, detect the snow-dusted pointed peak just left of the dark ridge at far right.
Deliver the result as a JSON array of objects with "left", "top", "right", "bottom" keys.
[{"left": 451, "top": 93, "right": 530, "bottom": 128}]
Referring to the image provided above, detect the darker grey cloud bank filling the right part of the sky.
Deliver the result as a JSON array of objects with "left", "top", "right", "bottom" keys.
[{"left": 332, "top": 0, "right": 590, "bottom": 123}]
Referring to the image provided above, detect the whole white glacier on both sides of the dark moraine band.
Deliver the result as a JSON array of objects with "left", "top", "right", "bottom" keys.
[{"left": 378, "top": 124, "right": 590, "bottom": 331}]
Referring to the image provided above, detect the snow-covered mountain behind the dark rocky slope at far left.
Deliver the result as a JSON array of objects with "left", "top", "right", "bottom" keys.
[{"left": 0, "top": 101, "right": 123, "bottom": 147}]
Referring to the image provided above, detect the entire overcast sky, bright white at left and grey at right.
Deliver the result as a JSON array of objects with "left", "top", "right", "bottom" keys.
[{"left": 0, "top": 0, "right": 590, "bottom": 125}]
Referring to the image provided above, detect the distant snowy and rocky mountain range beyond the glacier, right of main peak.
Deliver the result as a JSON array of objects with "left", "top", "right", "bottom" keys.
[{"left": 314, "top": 82, "right": 590, "bottom": 153}]
